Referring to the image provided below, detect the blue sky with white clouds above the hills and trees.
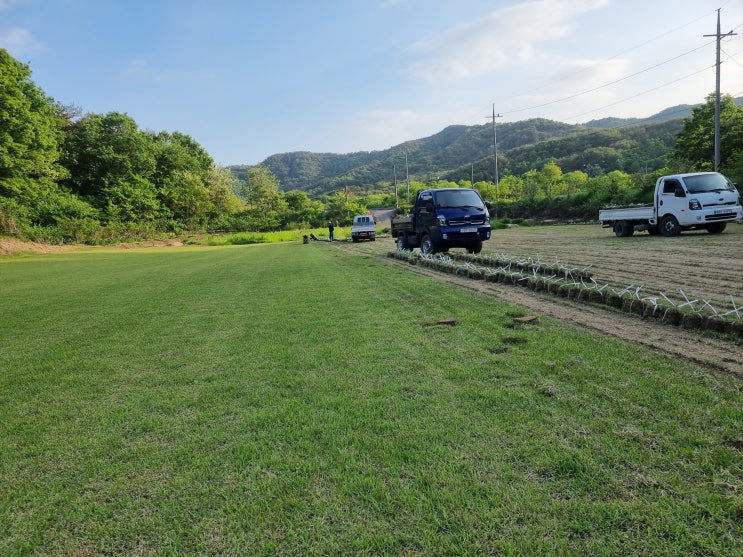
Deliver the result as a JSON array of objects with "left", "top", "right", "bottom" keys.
[{"left": 0, "top": 0, "right": 743, "bottom": 166}]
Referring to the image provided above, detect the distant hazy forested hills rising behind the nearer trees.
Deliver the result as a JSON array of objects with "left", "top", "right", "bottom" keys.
[{"left": 230, "top": 105, "right": 692, "bottom": 195}]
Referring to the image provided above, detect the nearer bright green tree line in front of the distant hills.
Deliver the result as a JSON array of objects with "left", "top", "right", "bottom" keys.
[{"left": 0, "top": 49, "right": 743, "bottom": 243}]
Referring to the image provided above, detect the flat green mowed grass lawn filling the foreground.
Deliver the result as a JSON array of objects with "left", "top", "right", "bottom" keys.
[{"left": 0, "top": 242, "right": 743, "bottom": 556}]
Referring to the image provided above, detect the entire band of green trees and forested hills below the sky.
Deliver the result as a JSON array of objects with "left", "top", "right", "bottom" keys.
[{"left": 0, "top": 49, "right": 743, "bottom": 243}]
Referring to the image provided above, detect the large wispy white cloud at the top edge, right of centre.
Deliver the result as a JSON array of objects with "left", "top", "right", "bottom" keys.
[{"left": 408, "top": 0, "right": 607, "bottom": 81}]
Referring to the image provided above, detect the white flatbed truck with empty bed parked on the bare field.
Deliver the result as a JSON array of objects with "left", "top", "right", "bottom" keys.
[{"left": 599, "top": 172, "right": 743, "bottom": 238}]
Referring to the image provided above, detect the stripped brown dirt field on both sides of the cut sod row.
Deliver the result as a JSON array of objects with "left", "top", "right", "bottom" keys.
[{"left": 336, "top": 224, "right": 743, "bottom": 379}]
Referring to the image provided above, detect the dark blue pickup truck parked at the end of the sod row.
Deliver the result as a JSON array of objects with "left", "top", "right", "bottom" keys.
[{"left": 390, "top": 188, "right": 490, "bottom": 253}]
